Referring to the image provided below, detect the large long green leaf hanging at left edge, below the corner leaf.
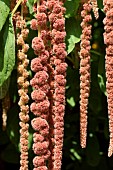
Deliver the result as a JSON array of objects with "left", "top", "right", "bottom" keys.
[{"left": 0, "top": 14, "right": 15, "bottom": 86}]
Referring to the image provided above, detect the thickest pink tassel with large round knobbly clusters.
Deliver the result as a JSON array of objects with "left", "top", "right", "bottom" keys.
[{"left": 30, "top": 0, "right": 50, "bottom": 170}]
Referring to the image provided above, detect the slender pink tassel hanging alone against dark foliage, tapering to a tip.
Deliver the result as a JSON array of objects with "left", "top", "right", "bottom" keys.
[{"left": 80, "top": 0, "right": 92, "bottom": 148}]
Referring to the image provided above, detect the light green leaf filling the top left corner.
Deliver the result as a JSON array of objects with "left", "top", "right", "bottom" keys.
[{"left": 0, "top": 0, "right": 10, "bottom": 31}]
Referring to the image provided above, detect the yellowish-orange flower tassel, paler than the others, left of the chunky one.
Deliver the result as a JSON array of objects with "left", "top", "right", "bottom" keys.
[{"left": 16, "top": 1, "right": 29, "bottom": 170}]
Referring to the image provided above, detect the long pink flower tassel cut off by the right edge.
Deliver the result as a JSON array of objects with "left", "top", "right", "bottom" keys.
[{"left": 103, "top": 0, "right": 113, "bottom": 157}]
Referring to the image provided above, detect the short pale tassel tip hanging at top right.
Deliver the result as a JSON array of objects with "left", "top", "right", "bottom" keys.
[{"left": 91, "top": 0, "right": 99, "bottom": 19}]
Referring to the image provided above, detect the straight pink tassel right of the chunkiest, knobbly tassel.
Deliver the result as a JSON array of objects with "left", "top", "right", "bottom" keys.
[{"left": 48, "top": 0, "right": 67, "bottom": 170}]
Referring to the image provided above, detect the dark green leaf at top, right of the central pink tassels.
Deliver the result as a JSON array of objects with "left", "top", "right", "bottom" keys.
[{"left": 65, "top": 0, "right": 80, "bottom": 18}]
